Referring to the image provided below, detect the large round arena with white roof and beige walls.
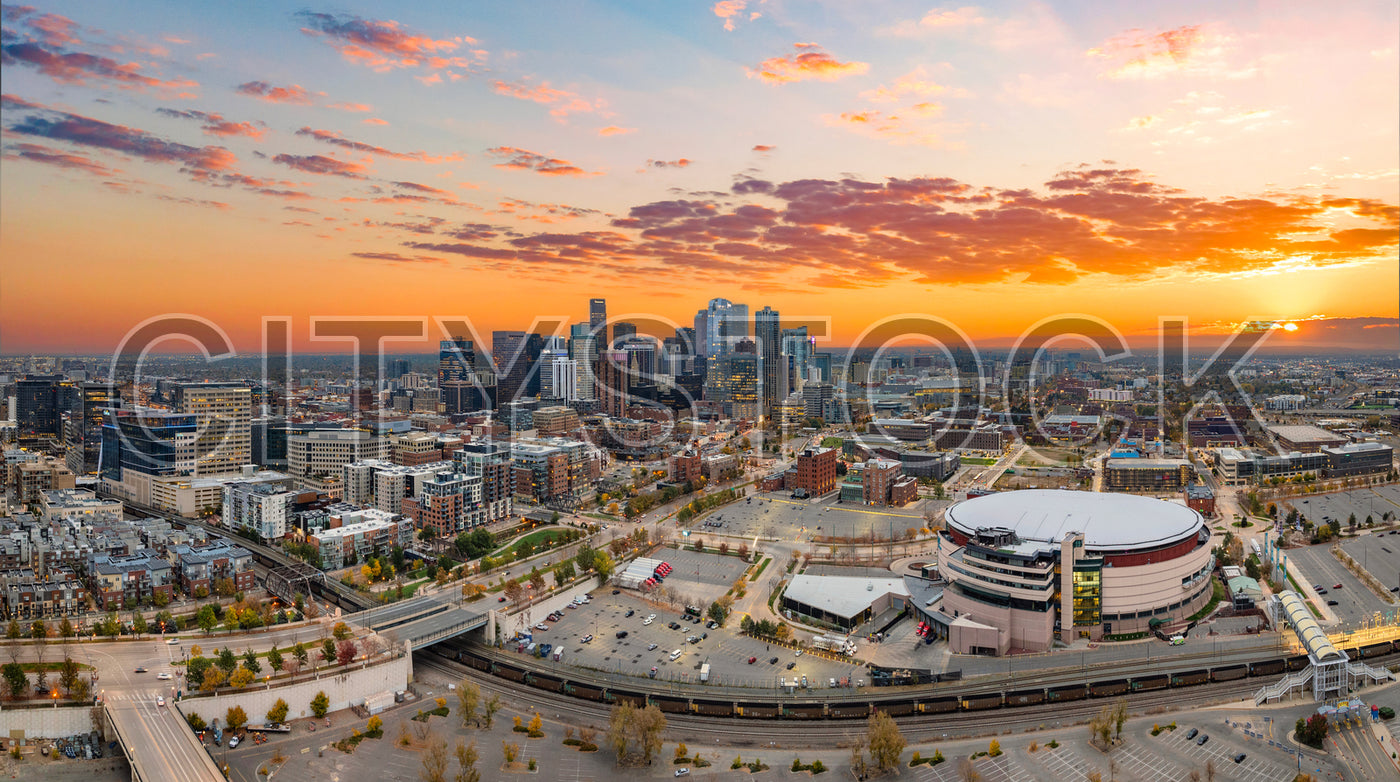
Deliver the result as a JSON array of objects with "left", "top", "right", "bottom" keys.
[{"left": 920, "top": 490, "right": 1214, "bottom": 655}]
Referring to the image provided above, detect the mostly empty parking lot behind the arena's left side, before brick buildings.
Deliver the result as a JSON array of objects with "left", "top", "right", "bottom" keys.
[{"left": 692, "top": 491, "right": 951, "bottom": 540}]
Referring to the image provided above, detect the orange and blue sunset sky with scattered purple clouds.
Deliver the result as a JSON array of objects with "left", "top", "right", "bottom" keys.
[{"left": 0, "top": 0, "right": 1400, "bottom": 354}]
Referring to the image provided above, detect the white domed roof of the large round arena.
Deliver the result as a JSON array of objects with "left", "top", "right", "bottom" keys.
[{"left": 946, "top": 488, "right": 1204, "bottom": 551}]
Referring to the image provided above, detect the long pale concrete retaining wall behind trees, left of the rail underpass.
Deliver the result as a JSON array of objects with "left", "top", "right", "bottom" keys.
[{"left": 178, "top": 656, "right": 413, "bottom": 725}]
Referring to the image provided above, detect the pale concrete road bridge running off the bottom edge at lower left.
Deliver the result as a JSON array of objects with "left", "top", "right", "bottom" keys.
[{"left": 105, "top": 701, "right": 224, "bottom": 782}]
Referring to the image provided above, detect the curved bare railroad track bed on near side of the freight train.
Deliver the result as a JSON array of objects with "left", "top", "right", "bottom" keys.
[{"left": 414, "top": 653, "right": 1282, "bottom": 747}]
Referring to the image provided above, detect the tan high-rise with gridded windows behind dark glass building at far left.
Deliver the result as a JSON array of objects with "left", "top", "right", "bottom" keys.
[{"left": 175, "top": 383, "right": 253, "bottom": 476}]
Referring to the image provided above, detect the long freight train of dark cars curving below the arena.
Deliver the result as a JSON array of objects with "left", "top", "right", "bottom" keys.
[{"left": 434, "top": 641, "right": 1400, "bottom": 719}]
